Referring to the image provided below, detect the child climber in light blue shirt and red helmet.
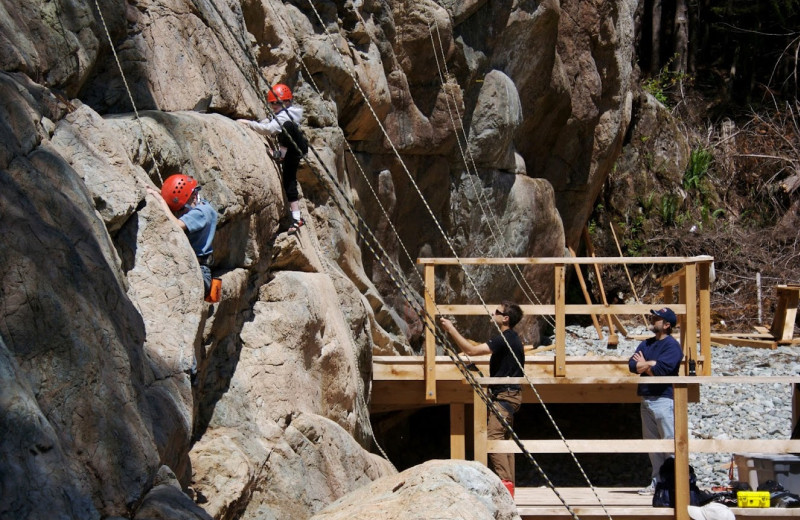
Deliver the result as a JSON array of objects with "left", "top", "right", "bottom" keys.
[{"left": 147, "top": 173, "right": 218, "bottom": 296}]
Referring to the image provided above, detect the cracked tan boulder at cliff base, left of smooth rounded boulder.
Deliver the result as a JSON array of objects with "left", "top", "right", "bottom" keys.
[{"left": 191, "top": 412, "right": 394, "bottom": 518}]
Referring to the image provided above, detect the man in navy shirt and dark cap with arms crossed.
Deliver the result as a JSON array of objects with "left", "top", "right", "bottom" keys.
[{"left": 628, "top": 307, "right": 683, "bottom": 495}]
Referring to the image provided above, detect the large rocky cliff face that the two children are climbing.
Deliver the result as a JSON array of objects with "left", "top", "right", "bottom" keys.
[{"left": 0, "top": 0, "right": 636, "bottom": 519}]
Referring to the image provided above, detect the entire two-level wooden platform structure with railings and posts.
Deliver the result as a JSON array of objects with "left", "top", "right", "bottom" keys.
[{"left": 371, "top": 256, "right": 800, "bottom": 520}]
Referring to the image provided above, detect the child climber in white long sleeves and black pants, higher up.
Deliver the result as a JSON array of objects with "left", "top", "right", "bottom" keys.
[{"left": 237, "top": 83, "right": 308, "bottom": 235}]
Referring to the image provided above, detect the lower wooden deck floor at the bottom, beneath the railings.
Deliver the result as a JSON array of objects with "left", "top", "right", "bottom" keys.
[{"left": 514, "top": 487, "right": 800, "bottom": 520}]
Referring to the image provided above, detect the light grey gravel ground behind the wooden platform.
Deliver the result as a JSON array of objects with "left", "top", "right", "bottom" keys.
[{"left": 552, "top": 326, "right": 800, "bottom": 489}]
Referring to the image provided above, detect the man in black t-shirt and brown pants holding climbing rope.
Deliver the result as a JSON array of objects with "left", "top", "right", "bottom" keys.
[{"left": 439, "top": 301, "right": 525, "bottom": 496}]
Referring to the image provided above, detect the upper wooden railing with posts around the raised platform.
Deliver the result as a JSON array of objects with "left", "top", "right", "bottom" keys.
[{"left": 417, "top": 256, "right": 713, "bottom": 402}]
